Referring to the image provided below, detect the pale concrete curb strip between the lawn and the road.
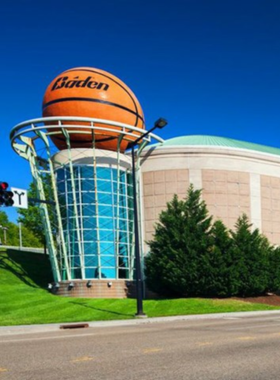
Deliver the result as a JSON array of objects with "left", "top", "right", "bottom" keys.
[{"left": 0, "top": 310, "right": 280, "bottom": 337}]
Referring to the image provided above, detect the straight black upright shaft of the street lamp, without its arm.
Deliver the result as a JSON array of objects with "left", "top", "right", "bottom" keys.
[{"left": 131, "top": 145, "right": 146, "bottom": 317}]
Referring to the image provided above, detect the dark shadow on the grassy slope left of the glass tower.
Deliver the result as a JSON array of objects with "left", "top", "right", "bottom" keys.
[{"left": 0, "top": 249, "right": 52, "bottom": 289}]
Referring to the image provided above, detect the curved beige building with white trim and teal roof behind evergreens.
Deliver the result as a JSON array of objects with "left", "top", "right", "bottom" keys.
[{"left": 141, "top": 136, "right": 280, "bottom": 251}]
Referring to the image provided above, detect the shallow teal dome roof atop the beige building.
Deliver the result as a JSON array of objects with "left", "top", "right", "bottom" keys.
[{"left": 157, "top": 135, "right": 280, "bottom": 156}]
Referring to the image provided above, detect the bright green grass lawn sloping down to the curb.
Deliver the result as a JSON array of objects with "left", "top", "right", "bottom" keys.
[{"left": 0, "top": 249, "right": 279, "bottom": 326}]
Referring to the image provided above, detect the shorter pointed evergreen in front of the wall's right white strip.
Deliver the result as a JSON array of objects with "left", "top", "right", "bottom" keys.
[{"left": 231, "top": 214, "right": 270, "bottom": 297}]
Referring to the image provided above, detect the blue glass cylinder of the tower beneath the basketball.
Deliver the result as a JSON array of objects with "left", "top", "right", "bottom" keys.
[{"left": 55, "top": 165, "right": 133, "bottom": 279}]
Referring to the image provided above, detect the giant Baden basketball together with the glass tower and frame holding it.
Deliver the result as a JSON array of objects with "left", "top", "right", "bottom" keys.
[{"left": 11, "top": 67, "right": 160, "bottom": 298}]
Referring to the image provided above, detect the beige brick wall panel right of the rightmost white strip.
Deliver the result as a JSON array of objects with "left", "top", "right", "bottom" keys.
[{"left": 261, "top": 175, "right": 280, "bottom": 244}]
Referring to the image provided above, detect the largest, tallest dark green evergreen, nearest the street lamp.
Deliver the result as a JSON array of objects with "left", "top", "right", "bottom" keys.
[{"left": 145, "top": 185, "right": 212, "bottom": 296}]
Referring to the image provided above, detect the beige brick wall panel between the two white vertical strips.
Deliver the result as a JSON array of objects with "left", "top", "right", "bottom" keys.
[{"left": 202, "top": 170, "right": 251, "bottom": 228}]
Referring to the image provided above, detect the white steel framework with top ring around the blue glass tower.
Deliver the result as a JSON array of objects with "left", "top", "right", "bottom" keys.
[{"left": 10, "top": 117, "right": 163, "bottom": 281}]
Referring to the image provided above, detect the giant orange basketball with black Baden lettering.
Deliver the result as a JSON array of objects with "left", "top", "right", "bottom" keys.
[{"left": 42, "top": 67, "right": 145, "bottom": 151}]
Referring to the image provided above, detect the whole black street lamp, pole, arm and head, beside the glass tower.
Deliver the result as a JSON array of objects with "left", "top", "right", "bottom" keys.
[{"left": 128, "top": 118, "right": 167, "bottom": 317}]
